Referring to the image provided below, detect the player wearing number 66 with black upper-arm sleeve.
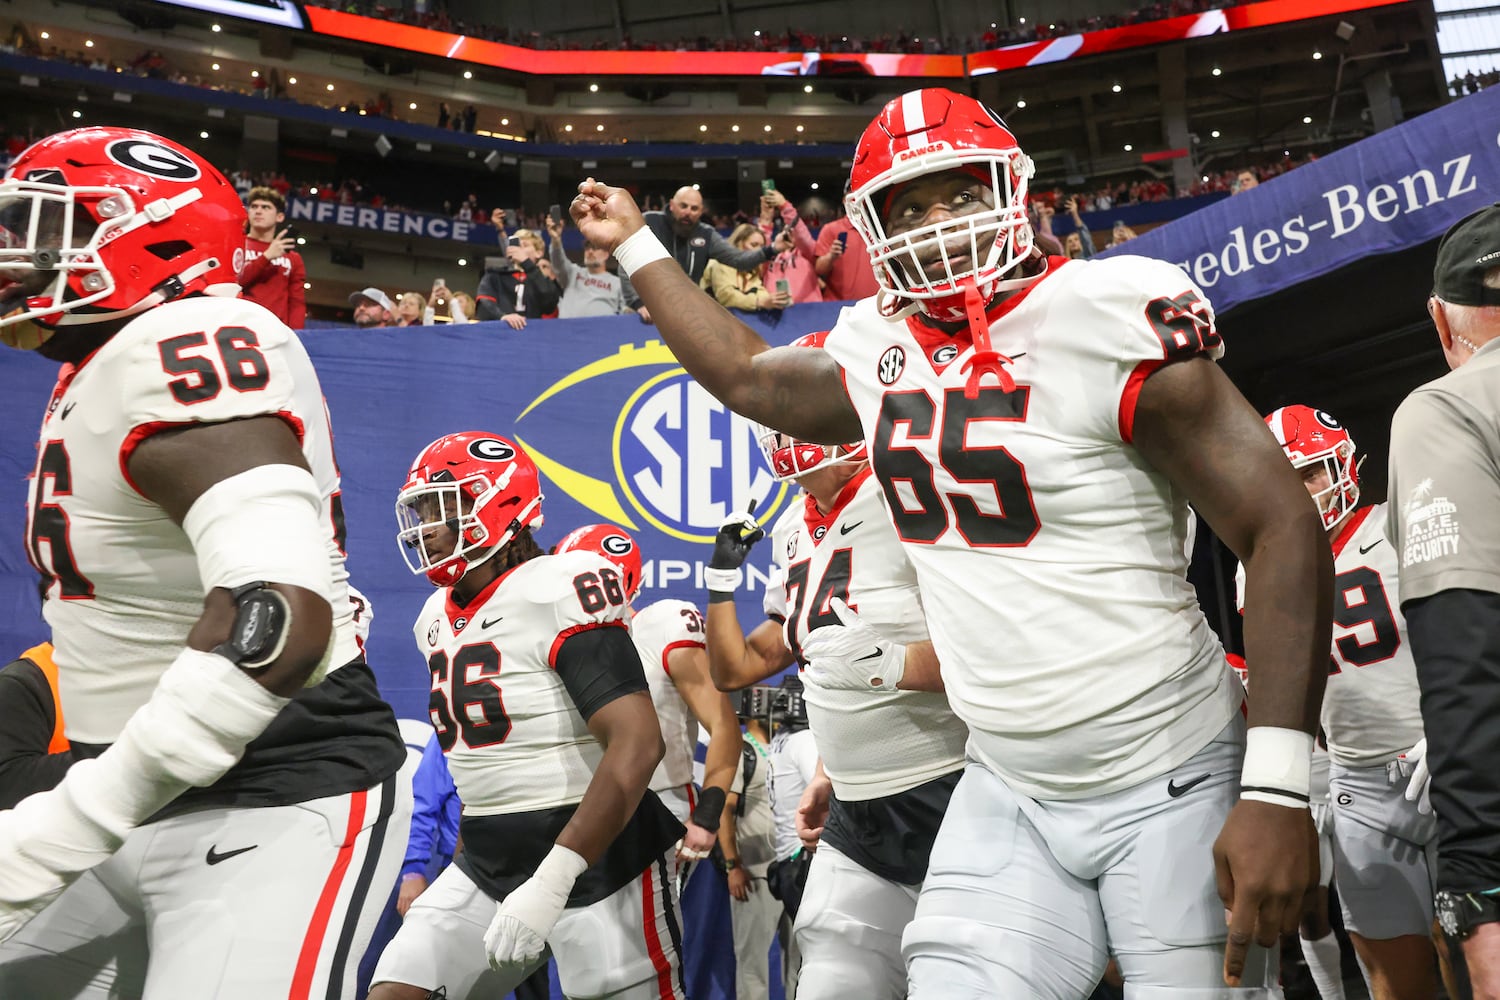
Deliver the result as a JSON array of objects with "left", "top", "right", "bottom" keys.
[{"left": 371, "top": 432, "right": 683, "bottom": 1000}]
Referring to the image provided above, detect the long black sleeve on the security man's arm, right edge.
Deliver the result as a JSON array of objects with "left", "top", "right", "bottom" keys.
[{"left": 1401, "top": 589, "right": 1500, "bottom": 892}]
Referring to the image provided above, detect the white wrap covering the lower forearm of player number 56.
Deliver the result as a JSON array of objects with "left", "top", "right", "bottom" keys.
[{"left": 0, "top": 649, "right": 287, "bottom": 900}]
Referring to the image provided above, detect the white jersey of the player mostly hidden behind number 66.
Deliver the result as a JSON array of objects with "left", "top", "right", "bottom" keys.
[{"left": 630, "top": 601, "right": 705, "bottom": 792}]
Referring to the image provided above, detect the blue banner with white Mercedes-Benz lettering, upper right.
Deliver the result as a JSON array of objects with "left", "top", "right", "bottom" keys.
[{"left": 1106, "top": 87, "right": 1500, "bottom": 312}]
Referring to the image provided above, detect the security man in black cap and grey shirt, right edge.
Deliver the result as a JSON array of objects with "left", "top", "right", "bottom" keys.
[{"left": 1386, "top": 204, "right": 1500, "bottom": 997}]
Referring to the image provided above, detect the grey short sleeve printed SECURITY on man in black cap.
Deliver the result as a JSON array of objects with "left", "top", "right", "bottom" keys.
[{"left": 1386, "top": 387, "right": 1500, "bottom": 604}]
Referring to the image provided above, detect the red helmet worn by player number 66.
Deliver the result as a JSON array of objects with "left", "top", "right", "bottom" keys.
[{"left": 396, "top": 430, "right": 542, "bottom": 586}]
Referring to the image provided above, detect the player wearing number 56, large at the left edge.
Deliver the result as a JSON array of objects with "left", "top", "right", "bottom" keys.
[{"left": 0, "top": 127, "right": 411, "bottom": 1000}]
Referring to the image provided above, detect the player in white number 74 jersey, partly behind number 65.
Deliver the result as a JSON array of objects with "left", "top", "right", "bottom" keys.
[{"left": 705, "top": 353, "right": 968, "bottom": 1000}]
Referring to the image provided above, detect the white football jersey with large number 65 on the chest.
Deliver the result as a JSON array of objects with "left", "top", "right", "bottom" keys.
[{"left": 827, "top": 256, "right": 1244, "bottom": 799}]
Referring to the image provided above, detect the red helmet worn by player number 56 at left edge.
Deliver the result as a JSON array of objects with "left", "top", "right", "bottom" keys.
[{"left": 0, "top": 127, "right": 245, "bottom": 340}]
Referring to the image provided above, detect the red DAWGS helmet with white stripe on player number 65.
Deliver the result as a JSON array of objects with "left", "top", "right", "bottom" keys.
[{"left": 845, "top": 87, "right": 1035, "bottom": 319}]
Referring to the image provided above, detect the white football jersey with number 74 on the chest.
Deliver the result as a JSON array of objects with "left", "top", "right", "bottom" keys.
[{"left": 768, "top": 469, "right": 969, "bottom": 802}]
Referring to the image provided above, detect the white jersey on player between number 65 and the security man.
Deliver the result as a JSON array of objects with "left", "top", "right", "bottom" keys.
[{"left": 1235, "top": 504, "right": 1422, "bottom": 768}]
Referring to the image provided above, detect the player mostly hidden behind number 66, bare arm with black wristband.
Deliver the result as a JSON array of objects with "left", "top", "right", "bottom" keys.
[{"left": 554, "top": 525, "right": 744, "bottom": 862}]
